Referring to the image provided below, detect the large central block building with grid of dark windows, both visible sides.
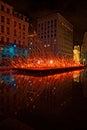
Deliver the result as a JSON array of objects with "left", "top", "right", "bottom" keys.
[{"left": 37, "top": 13, "right": 73, "bottom": 57}]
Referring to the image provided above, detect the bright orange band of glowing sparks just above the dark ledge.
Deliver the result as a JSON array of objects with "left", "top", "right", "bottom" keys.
[{"left": 11, "top": 56, "right": 83, "bottom": 69}]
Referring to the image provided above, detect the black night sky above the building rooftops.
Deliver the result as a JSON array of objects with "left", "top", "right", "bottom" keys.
[{"left": 3, "top": 0, "right": 87, "bottom": 43}]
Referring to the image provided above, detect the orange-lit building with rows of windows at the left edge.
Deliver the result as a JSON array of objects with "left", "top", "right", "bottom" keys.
[{"left": 0, "top": 1, "right": 29, "bottom": 46}]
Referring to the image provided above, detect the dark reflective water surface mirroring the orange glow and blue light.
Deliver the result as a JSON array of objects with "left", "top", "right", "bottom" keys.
[{"left": 0, "top": 70, "right": 87, "bottom": 130}]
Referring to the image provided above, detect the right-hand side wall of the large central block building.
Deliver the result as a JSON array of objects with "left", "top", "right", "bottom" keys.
[{"left": 57, "top": 13, "right": 73, "bottom": 57}]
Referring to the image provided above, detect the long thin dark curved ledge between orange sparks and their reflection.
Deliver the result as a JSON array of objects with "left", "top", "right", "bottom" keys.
[{"left": 12, "top": 66, "right": 85, "bottom": 76}]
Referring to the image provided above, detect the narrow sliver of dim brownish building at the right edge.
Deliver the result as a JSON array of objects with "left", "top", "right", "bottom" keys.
[{"left": 81, "top": 32, "right": 87, "bottom": 64}]
